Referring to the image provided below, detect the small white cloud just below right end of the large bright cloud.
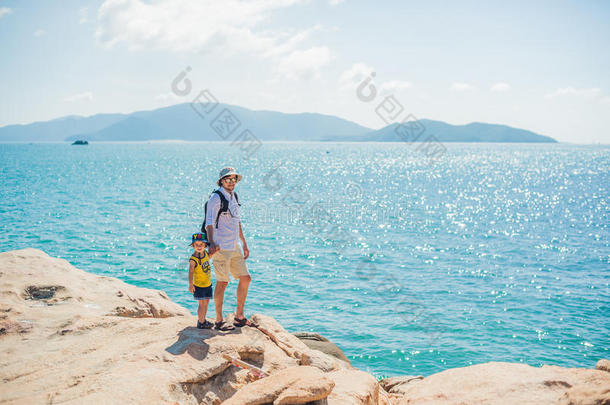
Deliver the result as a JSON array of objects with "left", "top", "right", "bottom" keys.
[{"left": 277, "top": 47, "right": 332, "bottom": 80}]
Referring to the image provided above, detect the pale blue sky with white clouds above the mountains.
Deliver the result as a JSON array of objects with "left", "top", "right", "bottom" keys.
[{"left": 0, "top": 0, "right": 610, "bottom": 143}]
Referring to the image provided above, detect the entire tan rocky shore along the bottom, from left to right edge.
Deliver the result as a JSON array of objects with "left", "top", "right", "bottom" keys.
[{"left": 0, "top": 249, "right": 610, "bottom": 405}]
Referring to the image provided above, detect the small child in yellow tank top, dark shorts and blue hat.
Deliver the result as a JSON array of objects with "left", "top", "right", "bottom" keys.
[{"left": 189, "top": 233, "right": 213, "bottom": 329}]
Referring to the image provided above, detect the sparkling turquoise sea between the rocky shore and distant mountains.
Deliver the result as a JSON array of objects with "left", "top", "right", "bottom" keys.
[{"left": 0, "top": 143, "right": 610, "bottom": 377}]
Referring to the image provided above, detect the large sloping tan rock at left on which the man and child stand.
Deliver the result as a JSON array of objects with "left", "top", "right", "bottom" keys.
[{"left": 0, "top": 249, "right": 342, "bottom": 404}]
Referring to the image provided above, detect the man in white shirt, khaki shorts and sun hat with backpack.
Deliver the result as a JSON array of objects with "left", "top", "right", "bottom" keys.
[{"left": 205, "top": 167, "right": 258, "bottom": 331}]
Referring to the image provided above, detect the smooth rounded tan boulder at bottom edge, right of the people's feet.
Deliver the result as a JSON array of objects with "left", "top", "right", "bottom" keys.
[{"left": 224, "top": 366, "right": 335, "bottom": 405}]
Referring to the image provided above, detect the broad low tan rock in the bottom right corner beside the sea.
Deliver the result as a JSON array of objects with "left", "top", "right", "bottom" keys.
[{"left": 395, "top": 362, "right": 610, "bottom": 405}]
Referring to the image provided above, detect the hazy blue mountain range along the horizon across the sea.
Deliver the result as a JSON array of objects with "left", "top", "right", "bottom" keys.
[{"left": 0, "top": 103, "right": 557, "bottom": 142}]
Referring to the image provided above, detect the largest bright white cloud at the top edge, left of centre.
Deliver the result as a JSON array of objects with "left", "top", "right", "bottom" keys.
[{"left": 96, "top": 0, "right": 306, "bottom": 55}]
